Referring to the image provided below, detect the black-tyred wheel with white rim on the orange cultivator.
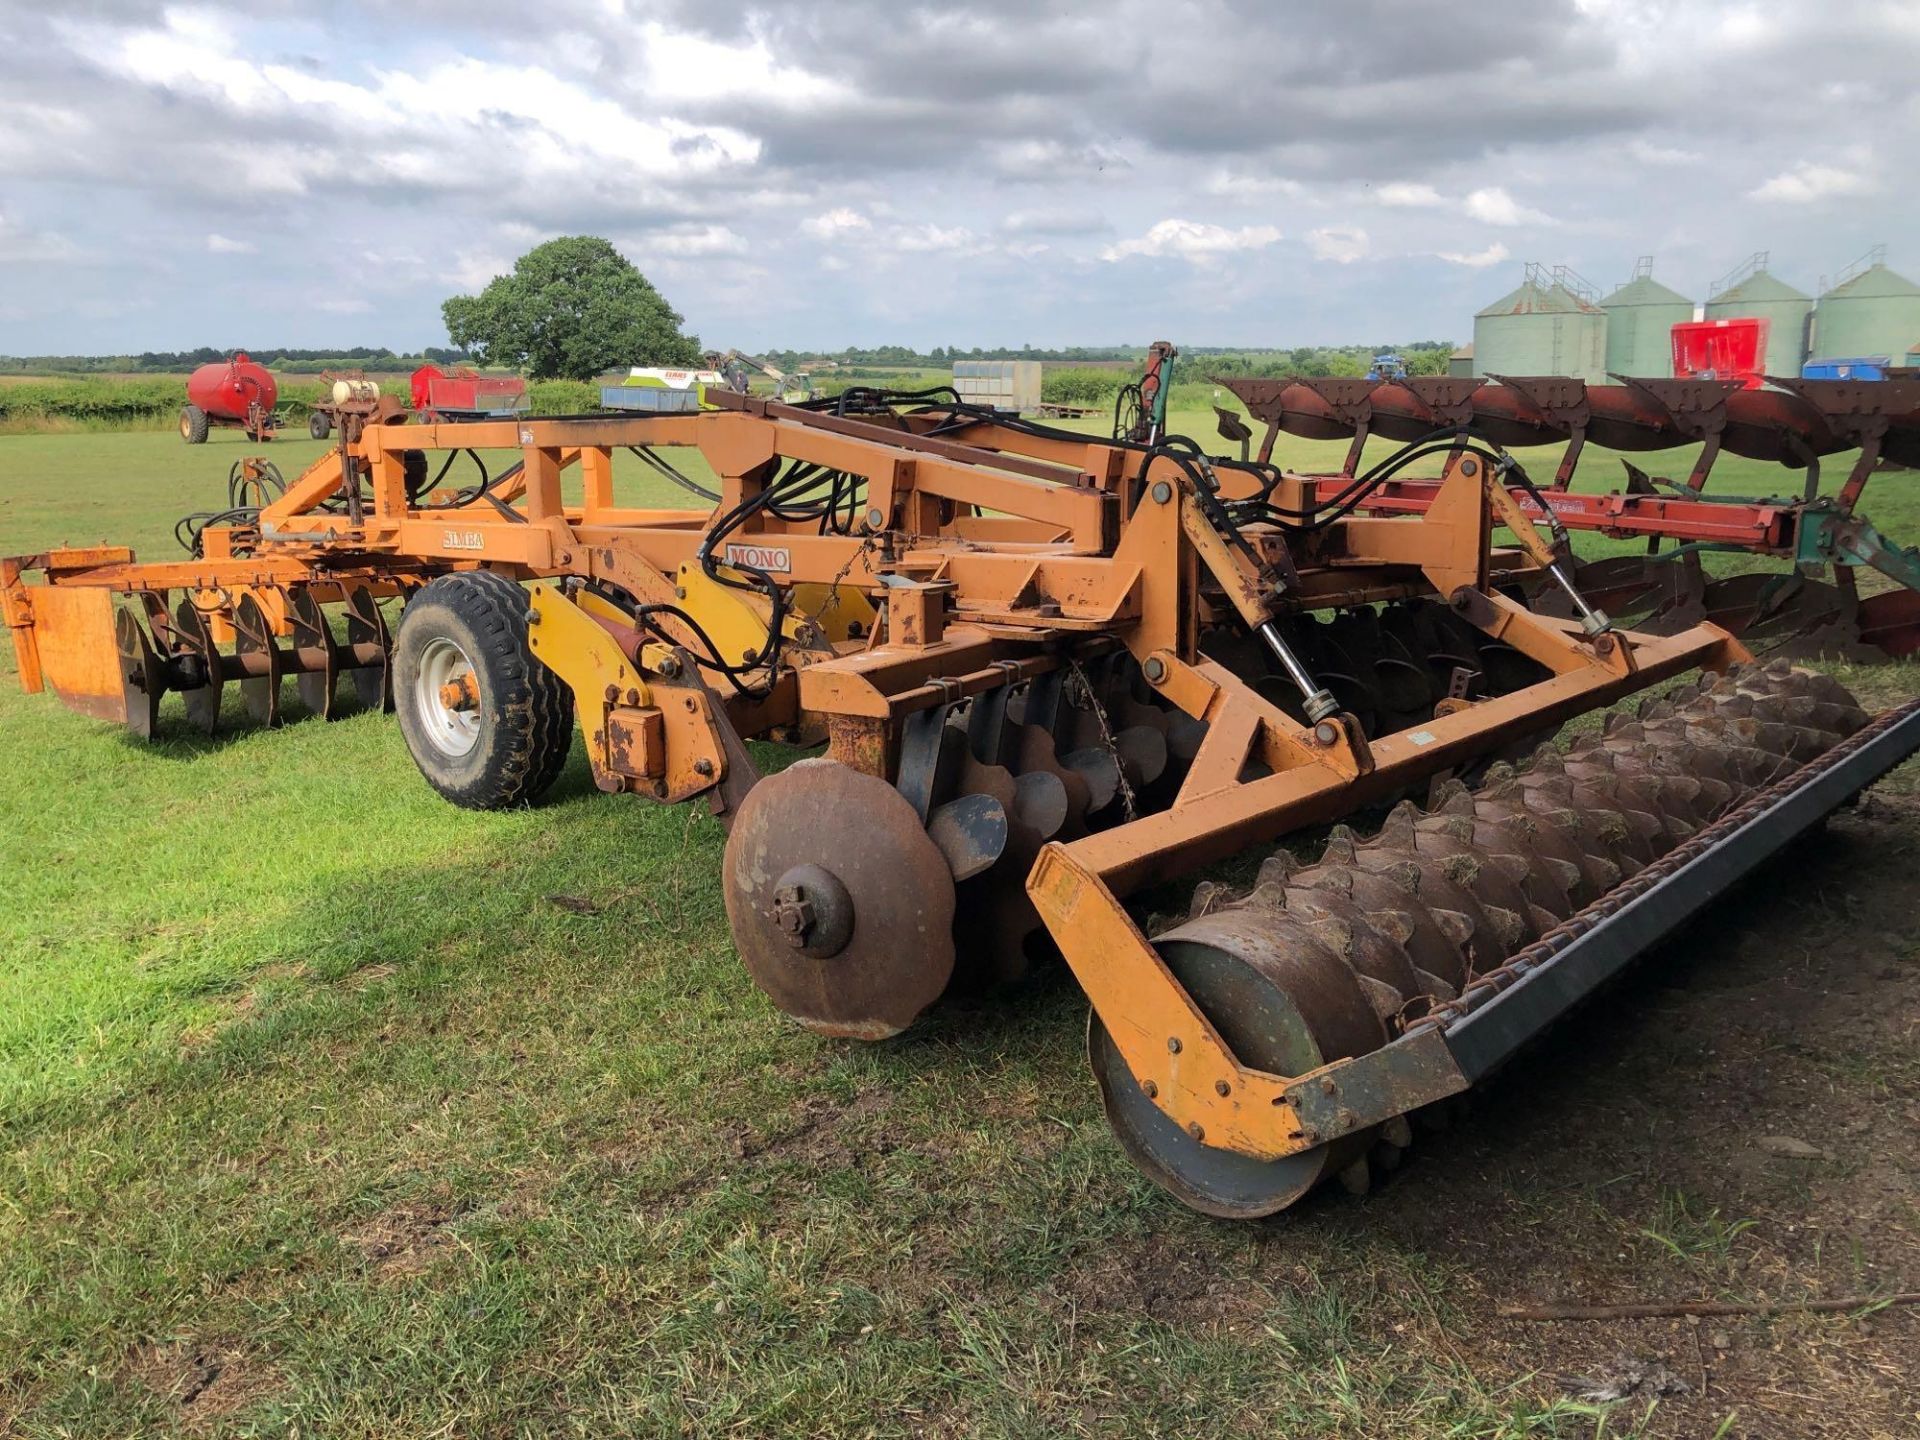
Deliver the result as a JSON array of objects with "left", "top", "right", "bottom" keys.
[{"left": 394, "top": 570, "right": 574, "bottom": 810}]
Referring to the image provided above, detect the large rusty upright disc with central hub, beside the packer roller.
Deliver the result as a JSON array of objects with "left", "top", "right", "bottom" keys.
[{"left": 724, "top": 760, "right": 954, "bottom": 1041}]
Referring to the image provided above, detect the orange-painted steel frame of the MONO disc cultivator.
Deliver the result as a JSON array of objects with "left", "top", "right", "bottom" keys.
[{"left": 0, "top": 397, "right": 1745, "bottom": 1158}]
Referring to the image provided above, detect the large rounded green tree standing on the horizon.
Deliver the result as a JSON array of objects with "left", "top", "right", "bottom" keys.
[{"left": 440, "top": 234, "right": 701, "bottom": 380}]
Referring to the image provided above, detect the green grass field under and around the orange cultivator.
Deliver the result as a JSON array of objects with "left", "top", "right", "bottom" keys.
[{"left": 0, "top": 415, "right": 1920, "bottom": 1436}]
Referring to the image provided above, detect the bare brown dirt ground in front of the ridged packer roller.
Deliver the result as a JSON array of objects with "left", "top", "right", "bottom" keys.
[{"left": 1351, "top": 806, "right": 1920, "bottom": 1440}]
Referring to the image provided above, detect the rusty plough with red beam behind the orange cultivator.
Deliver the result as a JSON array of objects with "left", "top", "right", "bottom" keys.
[{"left": 1221, "top": 376, "right": 1920, "bottom": 660}]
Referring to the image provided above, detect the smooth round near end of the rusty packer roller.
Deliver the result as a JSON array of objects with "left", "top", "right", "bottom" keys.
[{"left": 1087, "top": 912, "right": 1384, "bottom": 1219}]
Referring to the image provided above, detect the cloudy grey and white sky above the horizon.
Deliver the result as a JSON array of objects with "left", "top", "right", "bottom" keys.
[{"left": 0, "top": 0, "right": 1920, "bottom": 353}]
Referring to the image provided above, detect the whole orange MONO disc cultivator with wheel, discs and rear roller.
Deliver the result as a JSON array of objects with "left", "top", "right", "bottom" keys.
[{"left": 0, "top": 390, "right": 1920, "bottom": 1217}]
